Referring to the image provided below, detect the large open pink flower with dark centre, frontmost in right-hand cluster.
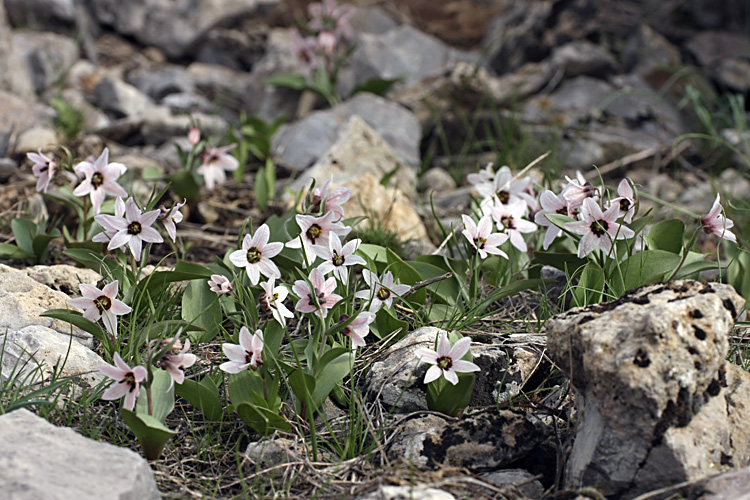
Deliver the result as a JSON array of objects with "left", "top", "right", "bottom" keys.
[{"left": 565, "top": 198, "right": 635, "bottom": 258}]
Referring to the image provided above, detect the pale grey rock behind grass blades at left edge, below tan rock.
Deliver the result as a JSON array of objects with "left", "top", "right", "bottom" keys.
[{"left": 0, "top": 325, "right": 106, "bottom": 387}]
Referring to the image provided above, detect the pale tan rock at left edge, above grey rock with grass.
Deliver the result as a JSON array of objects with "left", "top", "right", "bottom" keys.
[{"left": 0, "top": 272, "right": 92, "bottom": 346}]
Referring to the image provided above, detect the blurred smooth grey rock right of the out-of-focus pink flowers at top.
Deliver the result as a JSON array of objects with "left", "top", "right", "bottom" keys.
[{"left": 351, "top": 25, "right": 479, "bottom": 84}]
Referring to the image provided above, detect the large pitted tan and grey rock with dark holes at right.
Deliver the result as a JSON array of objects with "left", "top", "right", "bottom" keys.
[{"left": 546, "top": 281, "right": 750, "bottom": 497}]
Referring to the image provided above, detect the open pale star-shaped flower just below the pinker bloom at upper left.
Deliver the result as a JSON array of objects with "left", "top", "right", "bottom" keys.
[{"left": 102, "top": 198, "right": 164, "bottom": 261}]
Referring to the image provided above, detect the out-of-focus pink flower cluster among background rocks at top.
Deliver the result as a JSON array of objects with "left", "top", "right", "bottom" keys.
[{"left": 292, "top": 0, "right": 354, "bottom": 78}]
